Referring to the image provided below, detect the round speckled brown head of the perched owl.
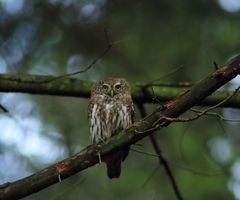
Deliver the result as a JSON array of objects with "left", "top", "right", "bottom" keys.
[{"left": 91, "top": 78, "right": 130, "bottom": 97}]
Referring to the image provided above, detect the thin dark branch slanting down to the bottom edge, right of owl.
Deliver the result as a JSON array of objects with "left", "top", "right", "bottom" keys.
[{"left": 138, "top": 104, "right": 183, "bottom": 200}]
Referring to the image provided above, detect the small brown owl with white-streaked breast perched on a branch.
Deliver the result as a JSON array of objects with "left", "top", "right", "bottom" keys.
[{"left": 88, "top": 78, "right": 134, "bottom": 178}]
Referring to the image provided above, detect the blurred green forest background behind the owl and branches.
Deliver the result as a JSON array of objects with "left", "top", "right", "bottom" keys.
[{"left": 0, "top": 0, "right": 240, "bottom": 200}]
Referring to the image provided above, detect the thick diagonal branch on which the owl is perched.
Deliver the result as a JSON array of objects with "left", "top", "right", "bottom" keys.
[{"left": 0, "top": 56, "right": 240, "bottom": 200}]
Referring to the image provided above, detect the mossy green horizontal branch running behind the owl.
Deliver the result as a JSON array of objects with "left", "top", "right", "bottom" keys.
[{"left": 0, "top": 71, "right": 240, "bottom": 108}]
